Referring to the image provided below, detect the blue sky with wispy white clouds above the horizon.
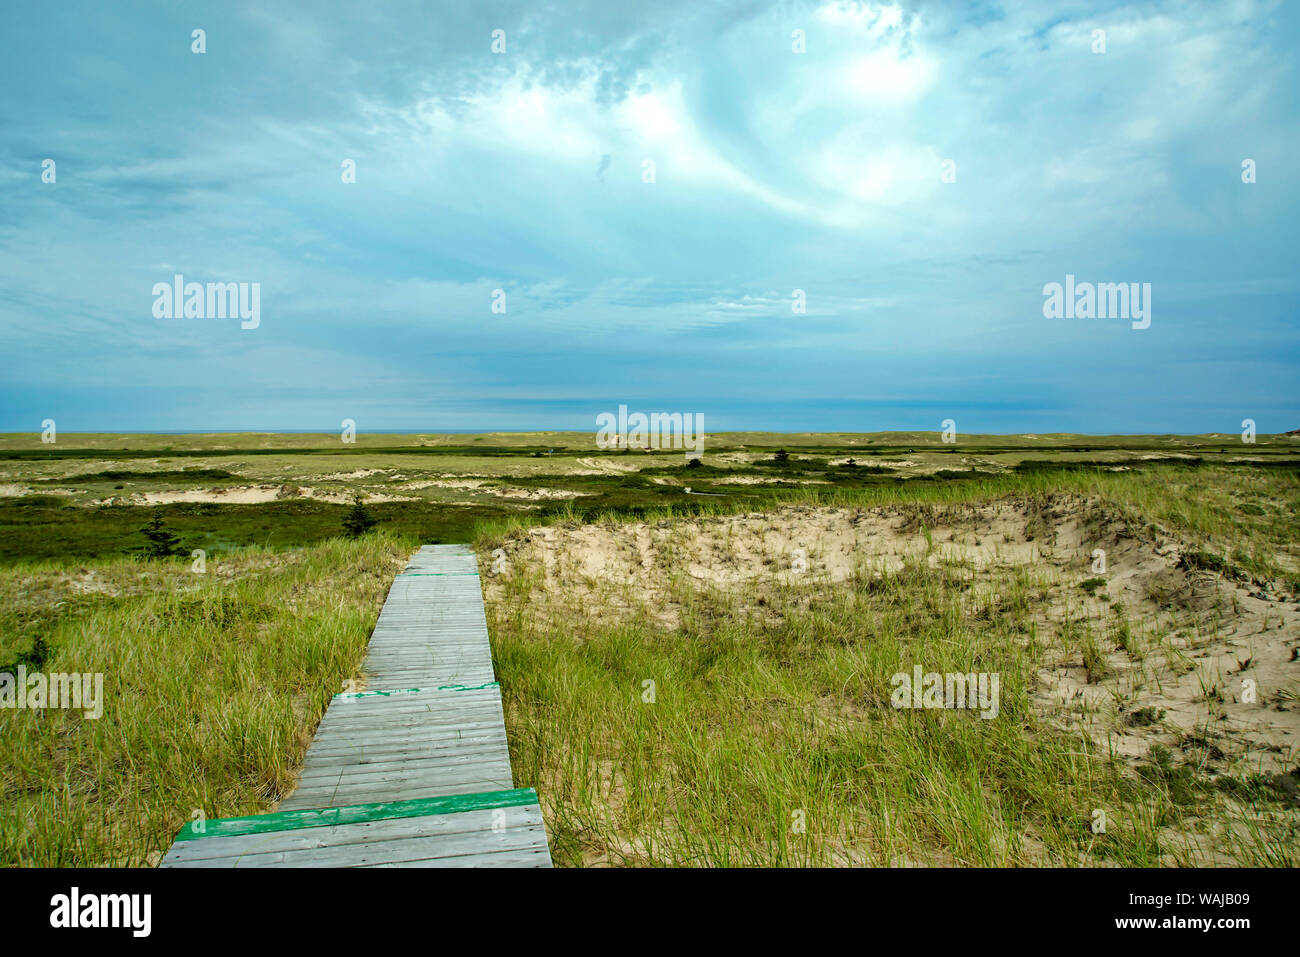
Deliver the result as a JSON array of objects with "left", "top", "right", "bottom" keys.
[{"left": 0, "top": 0, "right": 1300, "bottom": 433}]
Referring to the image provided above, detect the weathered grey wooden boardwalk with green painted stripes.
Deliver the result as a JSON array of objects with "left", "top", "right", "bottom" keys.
[{"left": 161, "top": 545, "right": 551, "bottom": 867}]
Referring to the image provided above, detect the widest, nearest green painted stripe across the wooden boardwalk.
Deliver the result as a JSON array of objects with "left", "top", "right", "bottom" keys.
[{"left": 176, "top": 788, "right": 537, "bottom": 841}]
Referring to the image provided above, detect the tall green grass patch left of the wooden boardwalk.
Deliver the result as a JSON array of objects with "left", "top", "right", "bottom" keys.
[{"left": 0, "top": 534, "right": 410, "bottom": 866}]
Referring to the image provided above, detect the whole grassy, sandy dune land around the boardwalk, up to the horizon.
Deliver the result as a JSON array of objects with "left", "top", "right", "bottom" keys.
[{"left": 0, "top": 433, "right": 1300, "bottom": 866}]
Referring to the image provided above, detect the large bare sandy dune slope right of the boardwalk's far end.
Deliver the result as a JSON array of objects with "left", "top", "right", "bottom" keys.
[{"left": 484, "top": 497, "right": 1300, "bottom": 772}]
